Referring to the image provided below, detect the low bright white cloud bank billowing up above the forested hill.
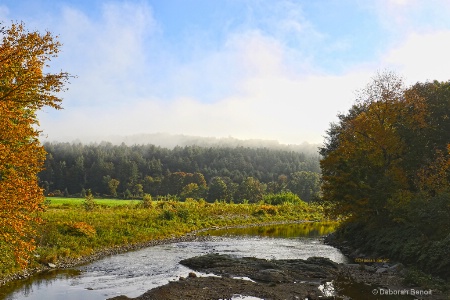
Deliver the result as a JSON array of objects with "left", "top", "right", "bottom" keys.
[{"left": 40, "top": 24, "right": 368, "bottom": 143}]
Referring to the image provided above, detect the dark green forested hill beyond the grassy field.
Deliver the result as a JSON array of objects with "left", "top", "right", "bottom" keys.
[{"left": 39, "top": 142, "right": 320, "bottom": 200}]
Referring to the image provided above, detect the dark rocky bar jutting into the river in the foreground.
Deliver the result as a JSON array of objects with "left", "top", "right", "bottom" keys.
[{"left": 113, "top": 254, "right": 338, "bottom": 300}]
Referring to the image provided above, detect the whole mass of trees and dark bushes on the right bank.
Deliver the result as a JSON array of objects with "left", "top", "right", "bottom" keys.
[{"left": 320, "top": 72, "right": 450, "bottom": 280}]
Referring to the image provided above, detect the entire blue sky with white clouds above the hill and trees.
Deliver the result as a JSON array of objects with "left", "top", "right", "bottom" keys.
[{"left": 0, "top": 0, "right": 450, "bottom": 144}]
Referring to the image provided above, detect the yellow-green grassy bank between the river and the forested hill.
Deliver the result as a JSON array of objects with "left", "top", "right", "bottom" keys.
[{"left": 0, "top": 198, "right": 330, "bottom": 277}]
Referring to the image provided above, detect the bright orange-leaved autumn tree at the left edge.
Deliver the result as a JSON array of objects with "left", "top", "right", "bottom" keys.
[{"left": 0, "top": 23, "right": 69, "bottom": 267}]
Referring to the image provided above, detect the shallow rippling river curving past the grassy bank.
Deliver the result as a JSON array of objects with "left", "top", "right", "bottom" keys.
[{"left": 0, "top": 223, "right": 414, "bottom": 300}]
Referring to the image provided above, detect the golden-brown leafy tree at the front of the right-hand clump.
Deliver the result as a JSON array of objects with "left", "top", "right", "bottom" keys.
[{"left": 320, "top": 73, "right": 427, "bottom": 218}]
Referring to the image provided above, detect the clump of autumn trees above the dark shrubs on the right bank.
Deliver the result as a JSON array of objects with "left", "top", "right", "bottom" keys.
[{"left": 320, "top": 72, "right": 450, "bottom": 230}]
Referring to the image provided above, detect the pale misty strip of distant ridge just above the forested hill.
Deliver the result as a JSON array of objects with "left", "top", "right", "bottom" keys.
[{"left": 51, "top": 133, "right": 320, "bottom": 155}]
